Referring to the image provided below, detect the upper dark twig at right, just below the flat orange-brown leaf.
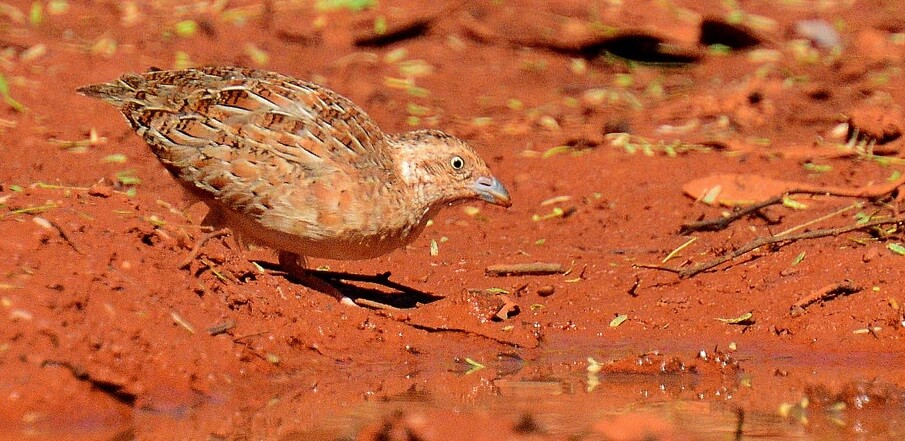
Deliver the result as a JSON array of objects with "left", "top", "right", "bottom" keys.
[{"left": 679, "top": 176, "right": 905, "bottom": 234}]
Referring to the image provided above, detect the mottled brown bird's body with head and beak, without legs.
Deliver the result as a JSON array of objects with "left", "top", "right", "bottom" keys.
[{"left": 79, "top": 67, "right": 510, "bottom": 300}]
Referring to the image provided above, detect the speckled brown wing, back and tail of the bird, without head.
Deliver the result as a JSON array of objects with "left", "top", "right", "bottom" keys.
[{"left": 82, "top": 67, "right": 395, "bottom": 237}]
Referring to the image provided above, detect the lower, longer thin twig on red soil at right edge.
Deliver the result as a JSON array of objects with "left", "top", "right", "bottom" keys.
[{"left": 635, "top": 215, "right": 905, "bottom": 279}]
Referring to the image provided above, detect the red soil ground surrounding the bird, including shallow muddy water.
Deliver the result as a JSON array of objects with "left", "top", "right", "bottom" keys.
[{"left": 0, "top": 0, "right": 905, "bottom": 440}]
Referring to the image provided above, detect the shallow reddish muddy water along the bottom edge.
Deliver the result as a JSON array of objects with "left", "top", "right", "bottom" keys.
[{"left": 15, "top": 348, "right": 905, "bottom": 440}]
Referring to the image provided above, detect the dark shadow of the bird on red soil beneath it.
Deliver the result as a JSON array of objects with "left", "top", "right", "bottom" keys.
[{"left": 255, "top": 261, "right": 444, "bottom": 309}]
